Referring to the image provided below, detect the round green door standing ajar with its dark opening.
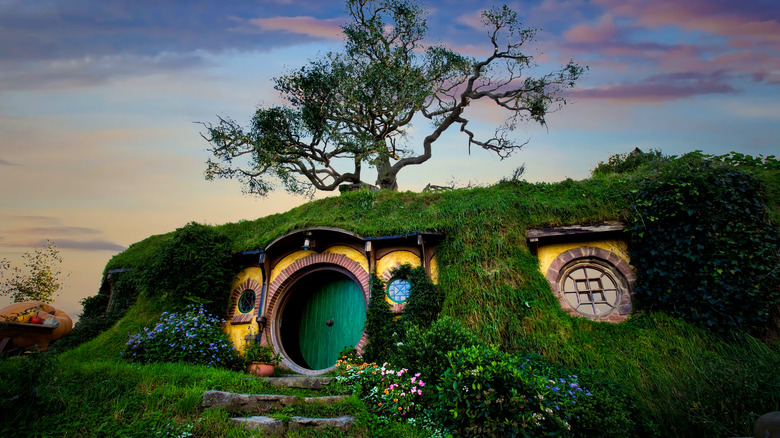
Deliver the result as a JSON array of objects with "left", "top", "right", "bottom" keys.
[{"left": 281, "top": 270, "right": 366, "bottom": 370}]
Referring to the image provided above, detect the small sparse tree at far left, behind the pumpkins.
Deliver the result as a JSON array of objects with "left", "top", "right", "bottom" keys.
[{"left": 0, "top": 240, "right": 67, "bottom": 303}]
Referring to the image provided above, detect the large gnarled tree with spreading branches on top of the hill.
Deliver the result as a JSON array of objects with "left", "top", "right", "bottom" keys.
[{"left": 201, "top": 0, "right": 584, "bottom": 195}]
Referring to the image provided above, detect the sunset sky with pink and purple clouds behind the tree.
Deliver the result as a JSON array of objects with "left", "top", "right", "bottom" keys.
[{"left": 0, "top": 0, "right": 780, "bottom": 317}]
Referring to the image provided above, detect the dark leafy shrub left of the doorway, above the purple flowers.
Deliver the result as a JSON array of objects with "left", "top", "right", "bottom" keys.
[{"left": 143, "top": 222, "right": 237, "bottom": 315}]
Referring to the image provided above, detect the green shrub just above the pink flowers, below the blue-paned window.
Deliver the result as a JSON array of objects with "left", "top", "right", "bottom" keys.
[{"left": 397, "top": 317, "right": 481, "bottom": 384}]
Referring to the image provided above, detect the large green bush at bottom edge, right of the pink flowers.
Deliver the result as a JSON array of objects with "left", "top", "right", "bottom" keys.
[{"left": 439, "top": 346, "right": 591, "bottom": 437}]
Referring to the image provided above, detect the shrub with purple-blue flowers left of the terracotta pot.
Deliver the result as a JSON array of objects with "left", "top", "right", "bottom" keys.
[{"left": 120, "top": 306, "right": 239, "bottom": 368}]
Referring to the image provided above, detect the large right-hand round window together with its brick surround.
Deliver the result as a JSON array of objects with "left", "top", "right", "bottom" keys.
[{"left": 547, "top": 246, "right": 636, "bottom": 322}]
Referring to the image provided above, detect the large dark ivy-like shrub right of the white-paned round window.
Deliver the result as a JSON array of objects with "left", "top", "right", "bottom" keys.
[{"left": 631, "top": 153, "right": 780, "bottom": 333}]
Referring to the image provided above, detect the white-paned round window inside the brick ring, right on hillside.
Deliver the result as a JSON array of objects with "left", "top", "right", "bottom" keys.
[{"left": 559, "top": 263, "right": 621, "bottom": 317}]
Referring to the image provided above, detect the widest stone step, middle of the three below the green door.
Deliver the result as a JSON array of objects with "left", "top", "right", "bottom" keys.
[{"left": 201, "top": 391, "right": 347, "bottom": 414}]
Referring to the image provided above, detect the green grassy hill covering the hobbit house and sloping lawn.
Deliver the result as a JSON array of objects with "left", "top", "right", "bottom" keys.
[{"left": 0, "top": 151, "right": 780, "bottom": 437}]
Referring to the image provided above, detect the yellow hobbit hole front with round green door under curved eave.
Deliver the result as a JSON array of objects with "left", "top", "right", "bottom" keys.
[{"left": 226, "top": 227, "right": 443, "bottom": 374}]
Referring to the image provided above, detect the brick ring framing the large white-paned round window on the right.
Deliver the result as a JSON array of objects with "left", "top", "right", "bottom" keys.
[{"left": 546, "top": 246, "right": 636, "bottom": 322}]
